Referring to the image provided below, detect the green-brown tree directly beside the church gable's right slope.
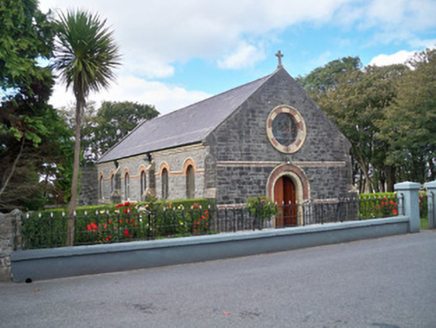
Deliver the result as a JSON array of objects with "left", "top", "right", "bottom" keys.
[{"left": 300, "top": 57, "right": 407, "bottom": 192}]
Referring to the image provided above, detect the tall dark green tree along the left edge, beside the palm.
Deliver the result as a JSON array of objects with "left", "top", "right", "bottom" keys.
[{"left": 0, "top": 0, "right": 54, "bottom": 210}]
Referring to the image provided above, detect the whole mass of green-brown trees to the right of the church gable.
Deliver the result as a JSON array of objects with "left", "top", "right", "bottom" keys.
[{"left": 298, "top": 50, "right": 436, "bottom": 192}]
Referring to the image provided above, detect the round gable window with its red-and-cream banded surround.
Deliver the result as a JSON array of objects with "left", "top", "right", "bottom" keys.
[{"left": 266, "top": 105, "right": 306, "bottom": 154}]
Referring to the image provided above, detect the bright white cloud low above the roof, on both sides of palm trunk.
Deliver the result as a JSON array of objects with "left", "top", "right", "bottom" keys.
[{"left": 50, "top": 76, "right": 211, "bottom": 115}]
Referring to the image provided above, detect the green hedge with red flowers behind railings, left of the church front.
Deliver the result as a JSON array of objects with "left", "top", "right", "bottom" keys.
[{"left": 22, "top": 199, "right": 210, "bottom": 248}]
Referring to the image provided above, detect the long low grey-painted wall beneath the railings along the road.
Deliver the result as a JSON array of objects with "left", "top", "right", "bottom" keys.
[{"left": 11, "top": 216, "right": 409, "bottom": 282}]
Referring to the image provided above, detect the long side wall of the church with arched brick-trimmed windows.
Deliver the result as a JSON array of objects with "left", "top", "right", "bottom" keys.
[{"left": 98, "top": 145, "right": 206, "bottom": 203}]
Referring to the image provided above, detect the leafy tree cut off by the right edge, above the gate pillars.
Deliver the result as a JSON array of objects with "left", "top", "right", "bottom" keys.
[{"left": 378, "top": 49, "right": 436, "bottom": 182}]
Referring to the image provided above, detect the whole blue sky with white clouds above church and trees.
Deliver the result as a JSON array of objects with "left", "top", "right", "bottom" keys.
[{"left": 39, "top": 0, "right": 436, "bottom": 114}]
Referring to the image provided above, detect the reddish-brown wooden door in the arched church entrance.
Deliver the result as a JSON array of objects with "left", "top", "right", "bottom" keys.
[{"left": 274, "top": 175, "right": 298, "bottom": 228}]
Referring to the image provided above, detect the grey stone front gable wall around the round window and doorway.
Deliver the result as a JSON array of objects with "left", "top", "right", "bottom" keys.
[{"left": 206, "top": 70, "right": 352, "bottom": 204}]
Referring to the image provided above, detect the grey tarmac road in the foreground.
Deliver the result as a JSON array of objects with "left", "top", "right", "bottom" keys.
[{"left": 0, "top": 231, "right": 436, "bottom": 328}]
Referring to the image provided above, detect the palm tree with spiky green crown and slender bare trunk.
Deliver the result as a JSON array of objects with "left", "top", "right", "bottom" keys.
[{"left": 54, "top": 11, "right": 120, "bottom": 246}]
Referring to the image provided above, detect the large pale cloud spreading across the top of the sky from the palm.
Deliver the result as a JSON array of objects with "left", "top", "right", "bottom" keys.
[{"left": 40, "top": 0, "right": 352, "bottom": 78}]
